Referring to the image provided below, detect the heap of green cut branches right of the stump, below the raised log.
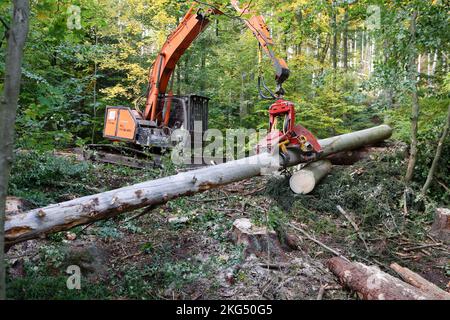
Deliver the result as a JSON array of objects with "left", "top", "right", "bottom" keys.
[{"left": 266, "top": 153, "right": 442, "bottom": 255}]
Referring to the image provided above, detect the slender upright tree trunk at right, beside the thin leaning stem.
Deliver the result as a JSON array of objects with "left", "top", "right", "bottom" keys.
[{"left": 405, "top": 11, "right": 419, "bottom": 183}]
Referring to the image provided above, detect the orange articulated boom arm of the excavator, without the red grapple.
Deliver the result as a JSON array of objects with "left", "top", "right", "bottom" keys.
[{"left": 142, "top": 0, "right": 289, "bottom": 126}]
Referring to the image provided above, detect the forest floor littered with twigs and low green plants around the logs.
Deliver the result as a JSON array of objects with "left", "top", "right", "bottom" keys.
[{"left": 7, "top": 148, "right": 450, "bottom": 299}]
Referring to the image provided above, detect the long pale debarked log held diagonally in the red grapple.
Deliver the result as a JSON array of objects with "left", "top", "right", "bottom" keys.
[{"left": 5, "top": 125, "right": 392, "bottom": 245}]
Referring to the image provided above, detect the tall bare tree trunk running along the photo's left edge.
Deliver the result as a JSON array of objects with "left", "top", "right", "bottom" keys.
[{"left": 0, "top": 0, "right": 30, "bottom": 300}]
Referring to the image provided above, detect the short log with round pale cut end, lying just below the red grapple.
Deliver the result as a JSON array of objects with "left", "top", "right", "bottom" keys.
[{"left": 289, "top": 160, "right": 331, "bottom": 194}]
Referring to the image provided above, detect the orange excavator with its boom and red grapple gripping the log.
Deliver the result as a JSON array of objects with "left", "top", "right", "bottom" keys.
[{"left": 103, "top": 0, "right": 321, "bottom": 161}]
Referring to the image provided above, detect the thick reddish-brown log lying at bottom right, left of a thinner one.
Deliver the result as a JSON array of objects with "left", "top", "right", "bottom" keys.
[{"left": 327, "top": 257, "right": 444, "bottom": 300}]
